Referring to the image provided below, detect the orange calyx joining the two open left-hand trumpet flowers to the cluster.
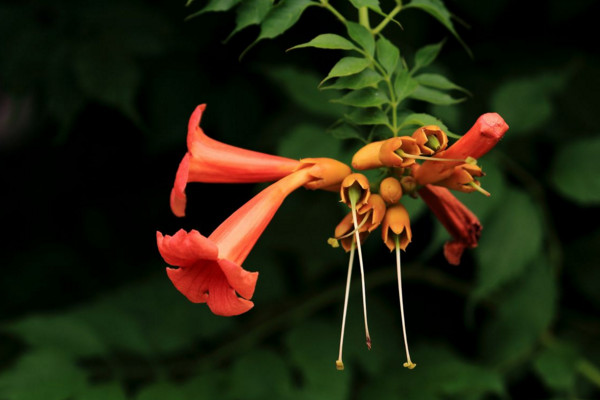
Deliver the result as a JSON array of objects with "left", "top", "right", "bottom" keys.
[{"left": 300, "top": 158, "right": 352, "bottom": 192}]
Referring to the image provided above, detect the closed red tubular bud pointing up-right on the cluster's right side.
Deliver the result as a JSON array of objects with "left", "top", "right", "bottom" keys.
[{"left": 414, "top": 113, "right": 508, "bottom": 185}]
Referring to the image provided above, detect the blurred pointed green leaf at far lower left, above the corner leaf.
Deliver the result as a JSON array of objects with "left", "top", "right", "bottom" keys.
[{"left": 7, "top": 316, "right": 107, "bottom": 357}]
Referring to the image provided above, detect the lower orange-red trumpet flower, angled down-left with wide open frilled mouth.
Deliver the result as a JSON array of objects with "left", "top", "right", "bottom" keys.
[{"left": 156, "top": 168, "right": 314, "bottom": 316}]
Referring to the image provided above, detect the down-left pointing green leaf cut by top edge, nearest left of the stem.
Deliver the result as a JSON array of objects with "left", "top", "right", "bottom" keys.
[{"left": 253, "top": 0, "right": 313, "bottom": 44}]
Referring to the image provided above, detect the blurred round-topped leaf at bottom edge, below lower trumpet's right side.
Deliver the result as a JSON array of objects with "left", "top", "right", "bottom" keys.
[{"left": 229, "top": 349, "right": 292, "bottom": 400}]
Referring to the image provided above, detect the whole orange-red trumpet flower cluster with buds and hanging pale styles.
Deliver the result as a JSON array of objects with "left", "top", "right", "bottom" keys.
[{"left": 157, "top": 105, "right": 508, "bottom": 369}]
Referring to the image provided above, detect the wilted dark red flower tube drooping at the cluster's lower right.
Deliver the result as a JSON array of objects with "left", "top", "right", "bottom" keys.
[{"left": 419, "top": 185, "right": 481, "bottom": 265}]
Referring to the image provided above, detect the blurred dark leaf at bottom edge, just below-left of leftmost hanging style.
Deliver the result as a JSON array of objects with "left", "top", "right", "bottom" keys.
[{"left": 285, "top": 322, "right": 351, "bottom": 400}]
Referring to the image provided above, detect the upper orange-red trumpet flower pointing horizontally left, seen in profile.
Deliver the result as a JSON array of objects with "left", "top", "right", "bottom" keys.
[{"left": 171, "top": 104, "right": 301, "bottom": 217}]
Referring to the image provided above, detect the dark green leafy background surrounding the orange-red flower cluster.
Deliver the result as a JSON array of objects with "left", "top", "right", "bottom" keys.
[{"left": 0, "top": 0, "right": 600, "bottom": 400}]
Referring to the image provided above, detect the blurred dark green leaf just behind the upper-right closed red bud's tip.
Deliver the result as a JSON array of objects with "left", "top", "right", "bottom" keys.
[{"left": 491, "top": 74, "right": 566, "bottom": 136}]
